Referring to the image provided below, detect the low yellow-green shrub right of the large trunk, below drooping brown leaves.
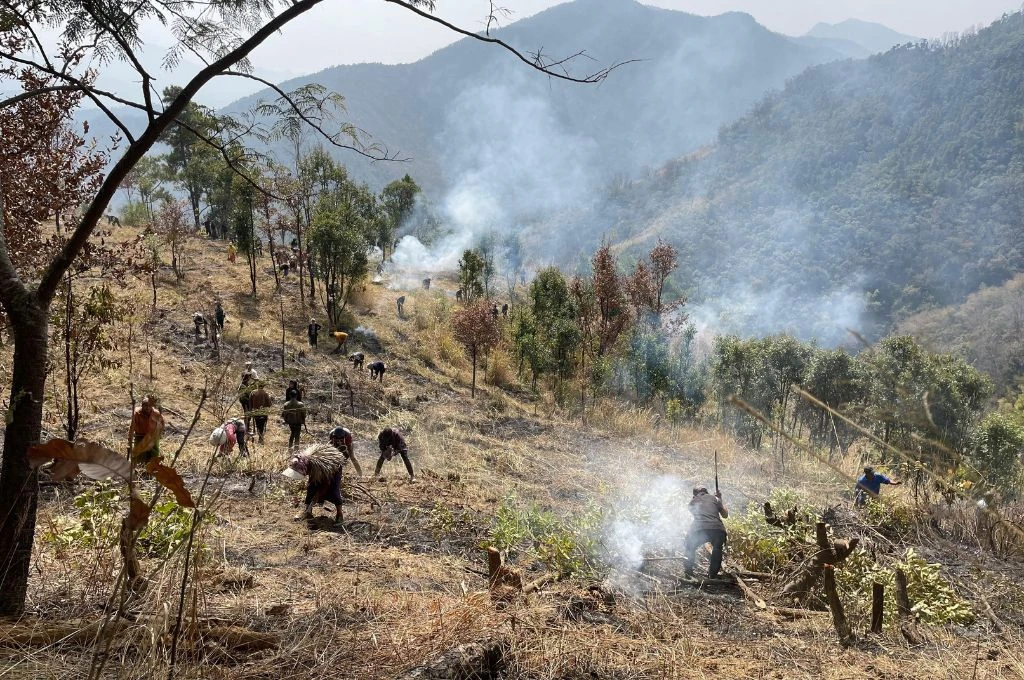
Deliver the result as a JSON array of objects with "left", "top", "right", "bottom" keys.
[{"left": 42, "top": 483, "right": 207, "bottom": 558}]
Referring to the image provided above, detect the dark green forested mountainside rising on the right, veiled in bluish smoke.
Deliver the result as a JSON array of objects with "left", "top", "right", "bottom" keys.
[{"left": 548, "top": 13, "right": 1024, "bottom": 346}]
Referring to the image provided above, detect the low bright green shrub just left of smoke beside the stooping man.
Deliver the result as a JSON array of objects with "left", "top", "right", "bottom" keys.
[{"left": 487, "top": 495, "right": 602, "bottom": 576}]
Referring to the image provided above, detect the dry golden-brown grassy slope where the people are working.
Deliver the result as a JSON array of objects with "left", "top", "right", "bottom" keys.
[{"left": 0, "top": 231, "right": 1024, "bottom": 678}]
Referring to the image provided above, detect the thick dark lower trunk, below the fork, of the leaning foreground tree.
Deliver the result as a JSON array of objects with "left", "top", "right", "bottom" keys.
[{"left": 0, "top": 301, "right": 47, "bottom": 617}]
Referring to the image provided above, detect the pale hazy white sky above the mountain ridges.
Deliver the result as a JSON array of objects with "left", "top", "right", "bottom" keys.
[{"left": 245, "top": 0, "right": 1021, "bottom": 76}]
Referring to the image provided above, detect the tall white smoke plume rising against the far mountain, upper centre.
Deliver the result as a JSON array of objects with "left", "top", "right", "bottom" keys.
[{"left": 388, "top": 74, "right": 599, "bottom": 285}]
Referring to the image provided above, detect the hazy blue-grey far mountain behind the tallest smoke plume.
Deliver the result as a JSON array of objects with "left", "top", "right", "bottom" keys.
[{"left": 220, "top": 0, "right": 846, "bottom": 189}]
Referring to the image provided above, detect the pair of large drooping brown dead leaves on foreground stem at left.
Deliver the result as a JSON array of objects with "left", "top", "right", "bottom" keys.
[{"left": 29, "top": 439, "right": 196, "bottom": 507}]
